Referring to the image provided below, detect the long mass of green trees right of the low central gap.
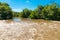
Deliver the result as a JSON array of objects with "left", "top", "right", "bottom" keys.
[{"left": 21, "top": 3, "right": 60, "bottom": 20}]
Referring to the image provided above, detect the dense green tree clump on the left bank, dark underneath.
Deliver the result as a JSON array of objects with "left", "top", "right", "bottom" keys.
[{"left": 0, "top": 2, "right": 12, "bottom": 19}]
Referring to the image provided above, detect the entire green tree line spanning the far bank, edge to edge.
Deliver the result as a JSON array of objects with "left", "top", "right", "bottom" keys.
[{"left": 0, "top": 2, "right": 60, "bottom": 20}]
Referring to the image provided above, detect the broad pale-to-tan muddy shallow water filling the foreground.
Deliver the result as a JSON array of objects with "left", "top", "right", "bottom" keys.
[{"left": 0, "top": 19, "right": 60, "bottom": 40}]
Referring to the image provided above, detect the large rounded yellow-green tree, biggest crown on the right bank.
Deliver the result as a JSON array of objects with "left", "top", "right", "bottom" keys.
[{"left": 42, "top": 4, "right": 58, "bottom": 20}]
